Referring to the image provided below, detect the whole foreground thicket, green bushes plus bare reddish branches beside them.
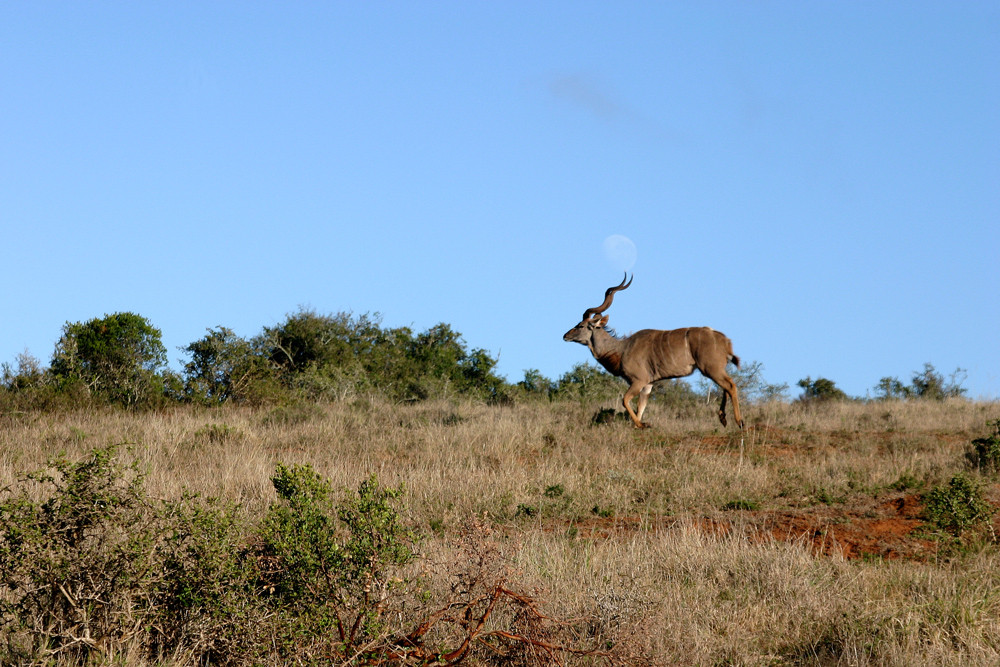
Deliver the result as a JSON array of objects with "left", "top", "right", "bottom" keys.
[{"left": 0, "top": 445, "right": 620, "bottom": 666}]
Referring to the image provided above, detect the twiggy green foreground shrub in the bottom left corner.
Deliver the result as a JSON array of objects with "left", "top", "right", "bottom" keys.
[{"left": 0, "top": 446, "right": 158, "bottom": 664}]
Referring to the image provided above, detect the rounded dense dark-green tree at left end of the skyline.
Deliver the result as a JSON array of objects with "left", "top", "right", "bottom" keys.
[{"left": 51, "top": 313, "right": 167, "bottom": 406}]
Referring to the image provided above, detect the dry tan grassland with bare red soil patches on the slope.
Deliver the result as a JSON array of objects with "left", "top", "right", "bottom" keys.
[{"left": 0, "top": 398, "right": 1000, "bottom": 665}]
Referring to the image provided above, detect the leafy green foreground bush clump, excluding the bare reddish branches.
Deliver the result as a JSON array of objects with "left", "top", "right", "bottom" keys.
[{"left": 0, "top": 446, "right": 415, "bottom": 665}]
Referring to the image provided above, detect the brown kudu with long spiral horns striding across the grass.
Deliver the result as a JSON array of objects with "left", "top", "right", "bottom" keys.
[{"left": 563, "top": 273, "right": 743, "bottom": 429}]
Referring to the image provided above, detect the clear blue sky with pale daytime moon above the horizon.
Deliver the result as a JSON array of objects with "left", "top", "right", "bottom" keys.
[{"left": 0, "top": 1, "right": 1000, "bottom": 398}]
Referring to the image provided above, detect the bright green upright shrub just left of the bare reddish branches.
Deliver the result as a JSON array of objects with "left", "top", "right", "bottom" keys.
[{"left": 260, "top": 464, "right": 415, "bottom": 659}]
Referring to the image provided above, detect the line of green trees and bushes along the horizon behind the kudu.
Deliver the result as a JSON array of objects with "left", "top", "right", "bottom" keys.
[{"left": 0, "top": 309, "right": 965, "bottom": 410}]
